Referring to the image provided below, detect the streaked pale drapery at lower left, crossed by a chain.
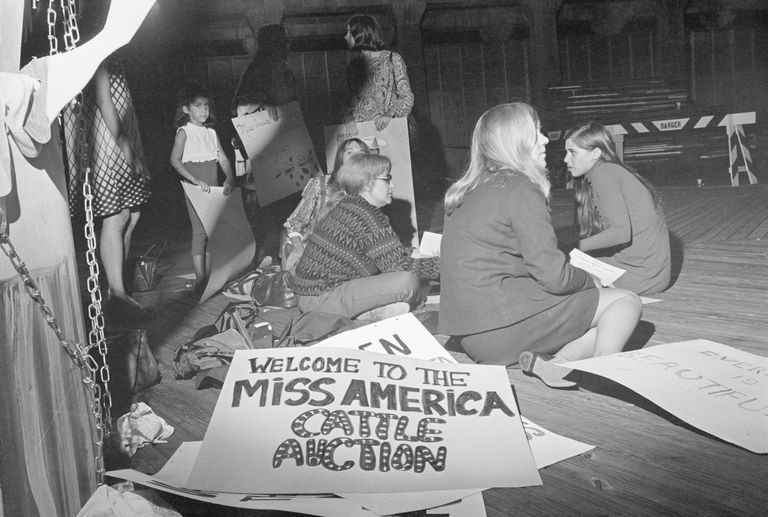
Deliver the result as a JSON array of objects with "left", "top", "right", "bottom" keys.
[{"left": 0, "top": 255, "right": 96, "bottom": 517}]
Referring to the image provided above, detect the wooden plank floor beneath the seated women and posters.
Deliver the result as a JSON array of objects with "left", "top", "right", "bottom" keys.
[{"left": 100, "top": 185, "right": 768, "bottom": 517}]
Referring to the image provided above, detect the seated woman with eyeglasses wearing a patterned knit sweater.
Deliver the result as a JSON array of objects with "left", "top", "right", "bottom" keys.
[{"left": 294, "top": 154, "right": 440, "bottom": 319}]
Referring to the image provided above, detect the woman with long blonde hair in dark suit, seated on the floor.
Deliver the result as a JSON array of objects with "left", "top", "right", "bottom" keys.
[{"left": 439, "top": 102, "right": 642, "bottom": 388}]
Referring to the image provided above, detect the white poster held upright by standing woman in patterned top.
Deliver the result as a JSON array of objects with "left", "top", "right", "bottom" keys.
[{"left": 325, "top": 118, "right": 419, "bottom": 248}]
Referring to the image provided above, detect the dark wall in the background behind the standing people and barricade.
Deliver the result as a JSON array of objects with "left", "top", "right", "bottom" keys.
[{"left": 19, "top": 0, "right": 768, "bottom": 228}]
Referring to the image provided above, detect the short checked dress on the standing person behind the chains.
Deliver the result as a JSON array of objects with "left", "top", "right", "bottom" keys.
[{"left": 65, "top": 61, "right": 150, "bottom": 217}]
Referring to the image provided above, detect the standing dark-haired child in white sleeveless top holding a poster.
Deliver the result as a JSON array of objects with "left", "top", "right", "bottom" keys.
[{"left": 171, "top": 83, "right": 235, "bottom": 287}]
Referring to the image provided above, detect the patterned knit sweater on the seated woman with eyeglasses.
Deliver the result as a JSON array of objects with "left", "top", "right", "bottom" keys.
[{"left": 294, "top": 196, "right": 440, "bottom": 296}]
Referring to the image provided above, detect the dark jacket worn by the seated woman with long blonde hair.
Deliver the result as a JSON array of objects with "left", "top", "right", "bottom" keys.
[{"left": 438, "top": 171, "right": 594, "bottom": 335}]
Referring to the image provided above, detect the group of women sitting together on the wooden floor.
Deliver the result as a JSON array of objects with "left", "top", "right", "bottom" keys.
[{"left": 286, "top": 103, "right": 671, "bottom": 388}]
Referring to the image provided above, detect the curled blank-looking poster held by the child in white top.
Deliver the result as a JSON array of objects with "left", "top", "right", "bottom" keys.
[{"left": 181, "top": 181, "right": 256, "bottom": 303}]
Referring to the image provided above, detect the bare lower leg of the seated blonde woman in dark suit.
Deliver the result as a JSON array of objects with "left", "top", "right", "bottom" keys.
[{"left": 555, "top": 289, "right": 643, "bottom": 362}]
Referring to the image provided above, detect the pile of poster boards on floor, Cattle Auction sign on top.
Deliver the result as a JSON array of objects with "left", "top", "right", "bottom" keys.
[{"left": 108, "top": 314, "right": 592, "bottom": 516}]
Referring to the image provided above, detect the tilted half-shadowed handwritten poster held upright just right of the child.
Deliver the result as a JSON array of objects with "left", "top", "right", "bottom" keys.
[{"left": 232, "top": 102, "right": 322, "bottom": 206}]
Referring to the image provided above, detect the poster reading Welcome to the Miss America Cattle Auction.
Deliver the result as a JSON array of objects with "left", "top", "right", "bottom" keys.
[{"left": 187, "top": 347, "right": 541, "bottom": 494}]
